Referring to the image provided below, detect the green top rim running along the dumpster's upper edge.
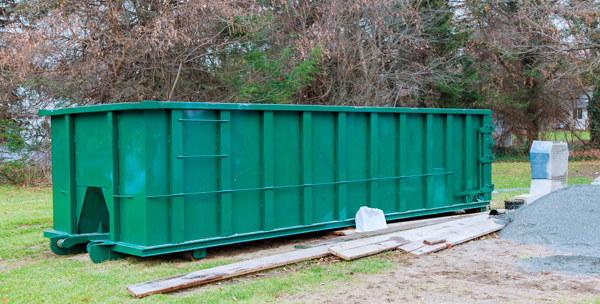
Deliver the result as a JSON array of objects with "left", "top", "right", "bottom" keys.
[{"left": 39, "top": 101, "right": 492, "bottom": 116}]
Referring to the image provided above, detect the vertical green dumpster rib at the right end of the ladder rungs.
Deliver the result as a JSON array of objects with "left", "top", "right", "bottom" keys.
[{"left": 219, "top": 110, "right": 233, "bottom": 236}]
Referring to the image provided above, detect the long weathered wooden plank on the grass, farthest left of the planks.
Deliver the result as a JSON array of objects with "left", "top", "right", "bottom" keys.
[{"left": 126, "top": 247, "right": 330, "bottom": 298}]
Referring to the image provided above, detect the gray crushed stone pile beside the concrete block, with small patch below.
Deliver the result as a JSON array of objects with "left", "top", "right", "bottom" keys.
[{"left": 496, "top": 185, "right": 600, "bottom": 274}]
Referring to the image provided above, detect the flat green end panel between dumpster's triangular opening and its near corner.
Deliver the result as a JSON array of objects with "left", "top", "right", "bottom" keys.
[{"left": 118, "top": 111, "right": 146, "bottom": 245}]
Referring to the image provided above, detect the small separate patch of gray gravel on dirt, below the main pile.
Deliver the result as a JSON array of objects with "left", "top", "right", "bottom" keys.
[{"left": 519, "top": 255, "right": 600, "bottom": 275}]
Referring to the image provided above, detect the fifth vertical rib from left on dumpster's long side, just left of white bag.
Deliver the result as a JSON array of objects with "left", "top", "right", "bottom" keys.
[{"left": 335, "top": 112, "right": 348, "bottom": 221}]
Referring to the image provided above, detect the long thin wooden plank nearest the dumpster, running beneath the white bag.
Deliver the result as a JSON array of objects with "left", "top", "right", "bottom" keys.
[{"left": 296, "top": 214, "right": 481, "bottom": 249}]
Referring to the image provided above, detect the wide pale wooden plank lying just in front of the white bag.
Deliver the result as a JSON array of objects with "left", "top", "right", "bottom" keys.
[{"left": 329, "top": 214, "right": 488, "bottom": 260}]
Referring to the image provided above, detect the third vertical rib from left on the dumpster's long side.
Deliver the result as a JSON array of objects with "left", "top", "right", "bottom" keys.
[{"left": 262, "top": 111, "right": 275, "bottom": 231}]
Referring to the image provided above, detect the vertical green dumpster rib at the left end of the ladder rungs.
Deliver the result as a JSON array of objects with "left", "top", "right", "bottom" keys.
[{"left": 169, "top": 110, "right": 185, "bottom": 244}]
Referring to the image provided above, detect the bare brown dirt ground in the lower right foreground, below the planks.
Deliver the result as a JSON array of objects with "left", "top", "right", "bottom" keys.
[{"left": 284, "top": 239, "right": 600, "bottom": 303}]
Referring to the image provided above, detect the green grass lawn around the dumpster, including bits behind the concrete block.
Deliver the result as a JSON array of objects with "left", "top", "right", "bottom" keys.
[{"left": 0, "top": 161, "right": 600, "bottom": 303}]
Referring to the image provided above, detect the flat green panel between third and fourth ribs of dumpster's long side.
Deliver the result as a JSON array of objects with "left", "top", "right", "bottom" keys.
[{"left": 274, "top": 112, "right": 302, "bottom": 228}]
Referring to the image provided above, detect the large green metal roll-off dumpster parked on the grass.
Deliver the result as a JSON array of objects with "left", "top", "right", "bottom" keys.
[{"left": 40, "top": 101, "right": 494, "bottom": 263}]
